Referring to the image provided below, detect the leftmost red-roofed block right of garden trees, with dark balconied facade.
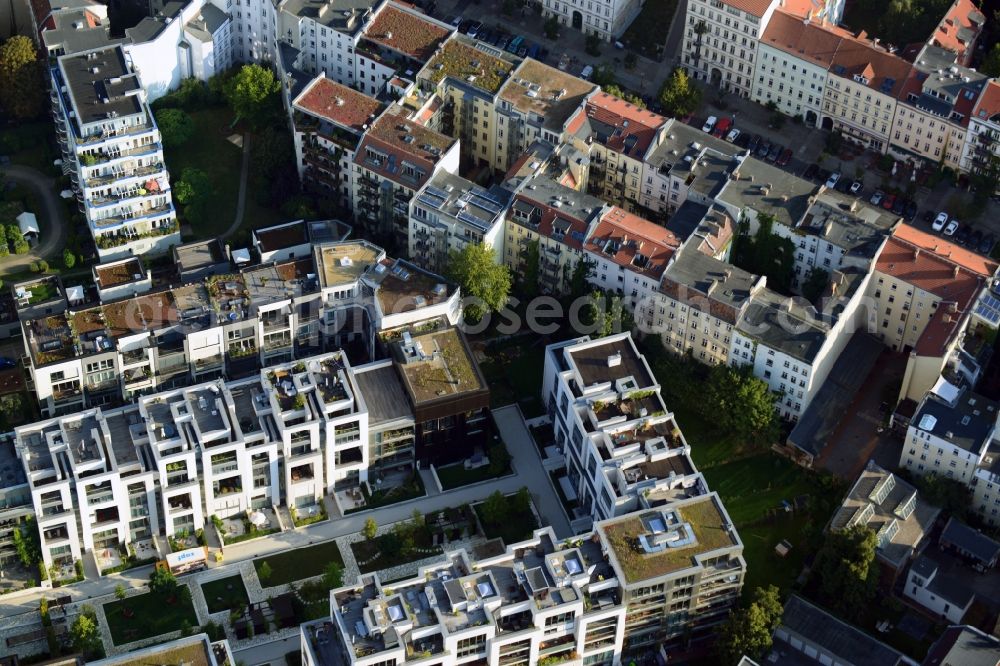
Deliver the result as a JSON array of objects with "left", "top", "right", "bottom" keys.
[{"left": 292, "top": 75, "right": 385, "bottom": 210}]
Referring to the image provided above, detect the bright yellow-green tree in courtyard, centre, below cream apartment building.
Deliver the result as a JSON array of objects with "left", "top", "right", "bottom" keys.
[{"left": 448, "top": 243, "right": 511, "bottom": 324}]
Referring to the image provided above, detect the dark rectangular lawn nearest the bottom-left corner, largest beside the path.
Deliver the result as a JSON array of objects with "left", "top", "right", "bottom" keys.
[{"left": 104, "top": 592, "right": 198, "bottom": 645}]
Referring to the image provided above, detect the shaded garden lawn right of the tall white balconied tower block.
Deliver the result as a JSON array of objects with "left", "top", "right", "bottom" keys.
[{"left": 163, "top": 107, "right": 245, "bottom": 238}]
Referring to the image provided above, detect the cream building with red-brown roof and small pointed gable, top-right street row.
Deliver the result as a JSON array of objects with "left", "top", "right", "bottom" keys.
[{"left": 820, "top": 39, "right": 911, "bottom": 153}]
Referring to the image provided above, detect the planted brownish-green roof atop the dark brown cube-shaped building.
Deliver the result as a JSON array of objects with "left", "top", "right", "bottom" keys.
[{"left": 396, "top": 328, "right": 486, "bottom": 403}]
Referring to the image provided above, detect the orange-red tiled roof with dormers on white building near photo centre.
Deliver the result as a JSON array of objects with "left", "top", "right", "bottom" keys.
[{"left": 585, "top": 206, "right": 681, "bottom": 279}]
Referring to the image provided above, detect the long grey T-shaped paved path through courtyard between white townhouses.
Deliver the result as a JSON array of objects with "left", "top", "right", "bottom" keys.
[{"left": 0, "top": 405, "right": 572, "bottom": 615}]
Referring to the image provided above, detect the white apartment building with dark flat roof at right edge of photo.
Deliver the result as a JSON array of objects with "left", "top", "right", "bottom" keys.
[{"left": 899, "top": 378, "right": 998, "bottom": 485}]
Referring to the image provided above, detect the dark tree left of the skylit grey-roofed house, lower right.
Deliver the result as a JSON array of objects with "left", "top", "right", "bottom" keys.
[{"left": 813, "top": 525, "right": 878, "bottom": 619}]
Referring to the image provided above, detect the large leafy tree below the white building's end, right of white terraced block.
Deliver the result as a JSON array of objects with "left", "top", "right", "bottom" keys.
[{"left": 699, "top": 365, "right": 777, "bottom": 444}]
